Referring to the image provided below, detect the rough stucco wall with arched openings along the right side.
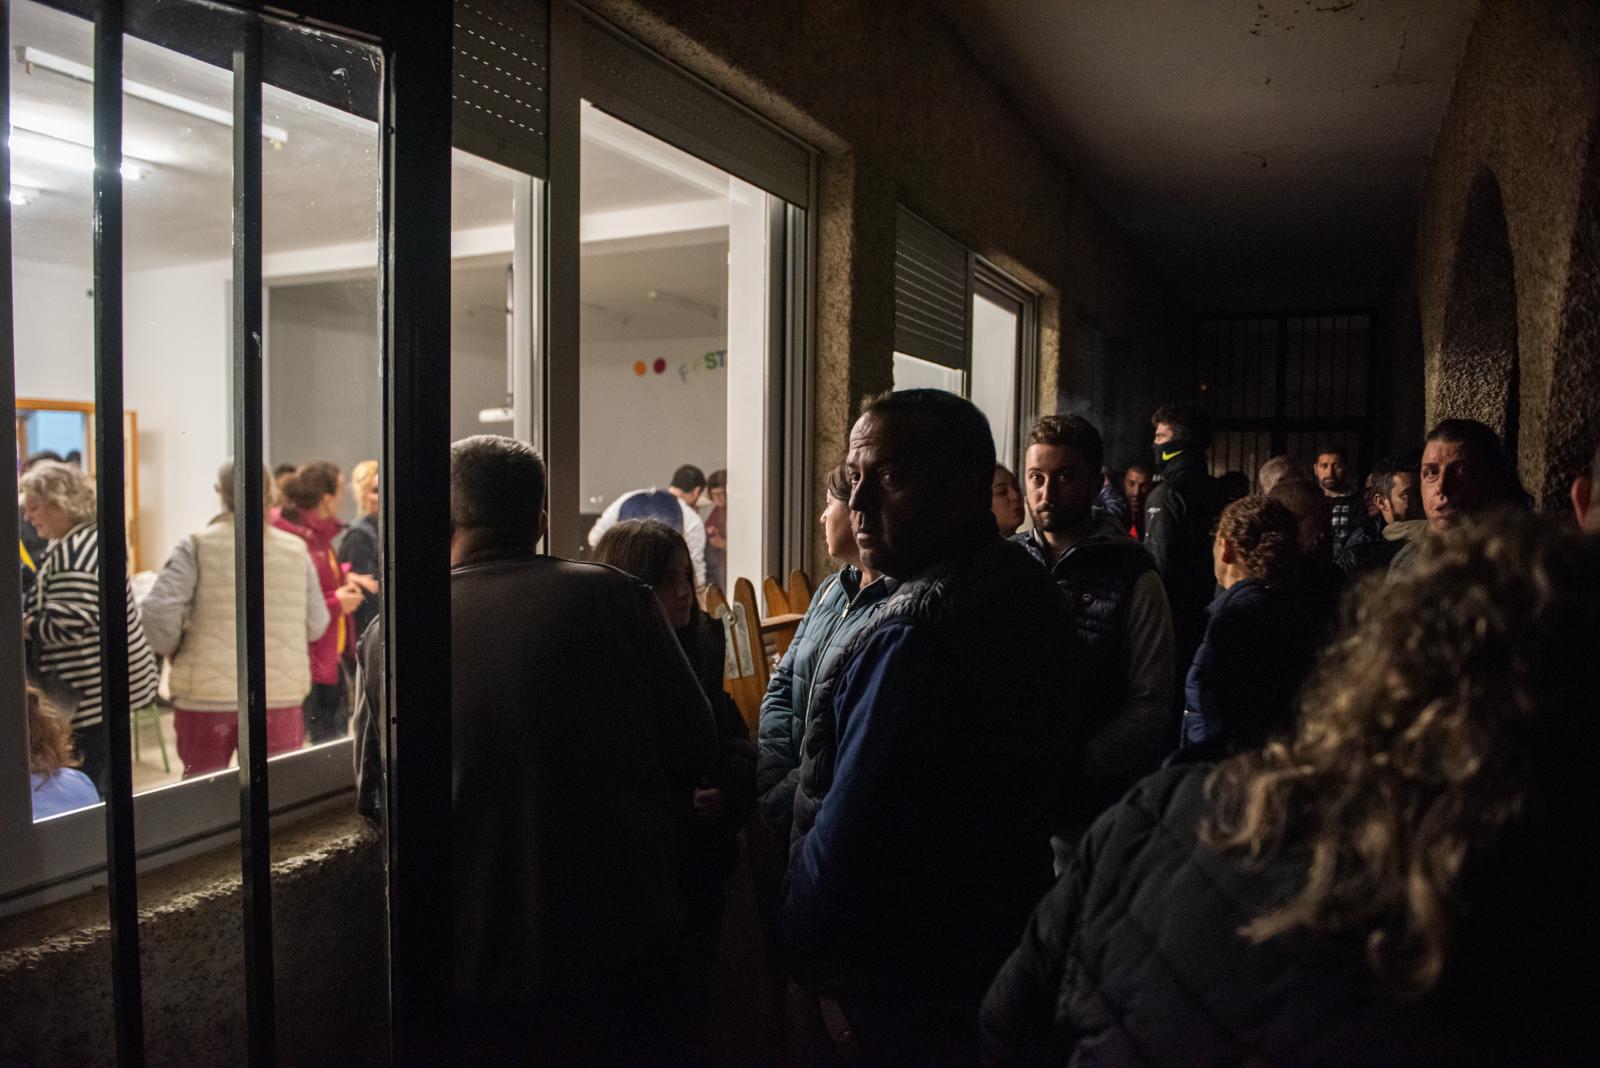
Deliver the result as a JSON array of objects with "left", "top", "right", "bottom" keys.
[{"left": 1418, "top": 0, "right": 1600, "bottom": 507}]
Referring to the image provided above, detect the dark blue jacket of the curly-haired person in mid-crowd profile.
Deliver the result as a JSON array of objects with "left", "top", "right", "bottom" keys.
[{"left": 1182, "top": 579, "right": 1315, "bottom": 755}]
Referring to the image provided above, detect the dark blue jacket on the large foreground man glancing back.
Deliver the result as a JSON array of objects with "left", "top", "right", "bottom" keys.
[{"left": 782, "top": 534, "right": 1082, "bottom": 1017}]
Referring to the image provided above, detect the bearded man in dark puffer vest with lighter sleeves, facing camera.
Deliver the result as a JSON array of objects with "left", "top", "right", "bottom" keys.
[{"left": 1011, "top": 416, "right": 1176, "bottom": 867}]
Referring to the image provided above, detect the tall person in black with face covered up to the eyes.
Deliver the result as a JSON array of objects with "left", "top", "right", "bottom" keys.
[{"left": 1144, "top": 404, "right": 1222, "bottom": 684}]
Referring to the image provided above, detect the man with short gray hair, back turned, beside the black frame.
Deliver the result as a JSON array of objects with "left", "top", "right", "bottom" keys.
[{"left": 357, "top": 435, "right": 717, "bottom": 1063}]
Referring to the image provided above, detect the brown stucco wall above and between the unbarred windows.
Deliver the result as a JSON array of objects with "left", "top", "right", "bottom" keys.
[{"left": 589, "top": 0, "right": 1186, "bottom": 568}]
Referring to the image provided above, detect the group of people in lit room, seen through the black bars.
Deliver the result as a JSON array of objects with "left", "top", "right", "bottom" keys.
[{"left": 18, "top": 454, "right": 379, "bottom": 808}]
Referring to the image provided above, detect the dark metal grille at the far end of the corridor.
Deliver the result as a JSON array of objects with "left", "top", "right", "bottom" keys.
[{"left": 1195, "top": 313, "right": 1374, "bottom": 478}]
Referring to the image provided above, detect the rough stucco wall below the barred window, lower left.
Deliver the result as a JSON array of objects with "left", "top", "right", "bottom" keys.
[{"left": 0, "top": 815, "right": 389, "bottom": 1065}]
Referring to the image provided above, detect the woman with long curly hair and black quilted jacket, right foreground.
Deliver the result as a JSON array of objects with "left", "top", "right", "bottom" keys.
[{"left": 982, "top": 516, "right": 1600, "bottom": 1065}]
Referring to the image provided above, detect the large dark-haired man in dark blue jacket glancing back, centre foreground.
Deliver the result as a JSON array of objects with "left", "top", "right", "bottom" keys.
[{"left": 782, "top": 390, "right": 1080, "bottom": 1063}]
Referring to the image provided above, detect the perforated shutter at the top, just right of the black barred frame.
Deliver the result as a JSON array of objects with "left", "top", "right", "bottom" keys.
[{"left": 450, "top": 0, "right": 550, "bottom": 177}]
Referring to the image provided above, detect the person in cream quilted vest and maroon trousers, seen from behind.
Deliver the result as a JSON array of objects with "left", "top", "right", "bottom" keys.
[{"left": 139, "top": 460, "right": 328, "bottom": 779}]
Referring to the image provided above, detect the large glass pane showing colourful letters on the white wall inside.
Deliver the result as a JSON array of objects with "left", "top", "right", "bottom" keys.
[{"left": 578, "top": 106, "right": 776, "bottom": 587}]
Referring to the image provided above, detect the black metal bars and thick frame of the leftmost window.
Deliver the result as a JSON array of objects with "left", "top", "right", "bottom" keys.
[{"left": 0, "top": 0, "right": 451, "bottom": 1065}]
